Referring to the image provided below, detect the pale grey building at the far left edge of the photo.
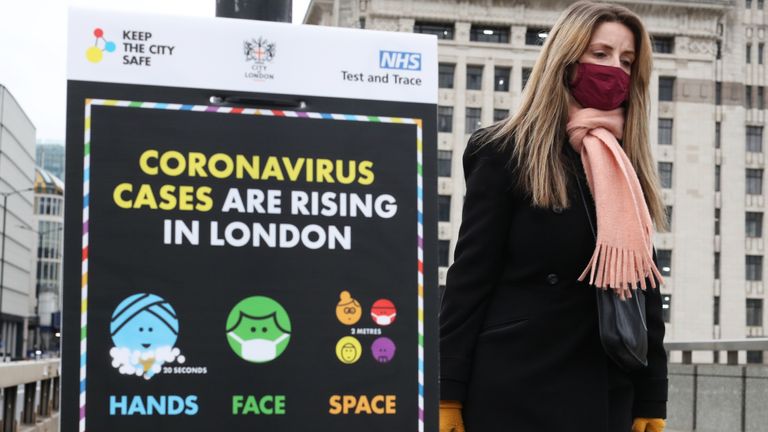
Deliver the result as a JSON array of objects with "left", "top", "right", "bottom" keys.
[{"left": 0, "top": 86, "right": 36, "bottom": 359}]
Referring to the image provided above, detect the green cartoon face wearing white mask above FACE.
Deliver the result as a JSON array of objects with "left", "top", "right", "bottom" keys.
[{"left": 227, "top": 296, "right": 291, "bottom": 363}]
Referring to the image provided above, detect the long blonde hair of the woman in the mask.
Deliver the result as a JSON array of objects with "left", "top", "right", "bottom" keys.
[{"left": 481, "top": 1, "right": 667, "bottom": 230}]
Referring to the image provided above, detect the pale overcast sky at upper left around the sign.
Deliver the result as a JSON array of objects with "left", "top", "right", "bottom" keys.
[{"left": 0, "top": 0, "right": 309, "bottom": 143}]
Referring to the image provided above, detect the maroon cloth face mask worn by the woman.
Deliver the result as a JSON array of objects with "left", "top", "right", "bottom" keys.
[{"left": 571, "top": 63, "right": 629, "bottom": 111}]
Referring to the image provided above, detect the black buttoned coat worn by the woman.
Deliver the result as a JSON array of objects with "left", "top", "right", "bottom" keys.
[{"left": 440, "top": 132, "right": 667, "bottom": 432}]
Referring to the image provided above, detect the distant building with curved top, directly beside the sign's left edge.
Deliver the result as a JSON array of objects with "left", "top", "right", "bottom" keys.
[{"left": 30, "top": 167, "right": 64, "bottom": 352}]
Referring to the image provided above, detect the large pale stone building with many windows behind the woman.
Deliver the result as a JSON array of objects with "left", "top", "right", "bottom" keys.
[{"left": 305, "top": 0, "right": 768, "bottom": 363}]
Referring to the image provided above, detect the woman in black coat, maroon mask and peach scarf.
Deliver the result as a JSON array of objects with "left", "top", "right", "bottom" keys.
[{"left": 440, "top": 1, "right": 667, "bottom": 432}]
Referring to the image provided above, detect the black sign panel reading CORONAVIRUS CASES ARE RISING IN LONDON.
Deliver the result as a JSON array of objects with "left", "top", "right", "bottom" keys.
[{"left": 62, "top": 82, "right": 437, "bottom": 432}]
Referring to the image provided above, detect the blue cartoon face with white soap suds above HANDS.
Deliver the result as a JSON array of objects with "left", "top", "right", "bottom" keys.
[{"left": 109, "top": 293, "right": 184, "bottom": 379}]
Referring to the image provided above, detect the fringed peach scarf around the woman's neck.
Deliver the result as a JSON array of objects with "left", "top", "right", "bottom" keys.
[{"left": 566, "top": 104, "right": 664, "bottom": 299}]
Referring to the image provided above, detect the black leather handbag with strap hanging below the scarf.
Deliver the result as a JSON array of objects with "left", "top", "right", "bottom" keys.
[{"left": 576, "top": 175, "right": 648, "bottom": 372}]
